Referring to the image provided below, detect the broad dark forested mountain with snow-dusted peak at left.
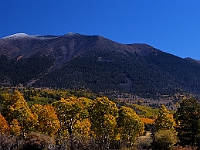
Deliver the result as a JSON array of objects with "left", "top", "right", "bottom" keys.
[{"left": 0, "top": 33, "right": 200, "bottom": 98}]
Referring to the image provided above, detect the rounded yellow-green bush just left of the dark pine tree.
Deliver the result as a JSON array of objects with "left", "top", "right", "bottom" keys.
[{"left": 154, "top": 130, "right": 178, "bottom": 150}]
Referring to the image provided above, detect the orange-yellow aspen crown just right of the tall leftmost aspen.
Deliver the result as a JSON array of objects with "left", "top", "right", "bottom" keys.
[{"left": 31, "top": 104, "right": 60, "bottom": 136}]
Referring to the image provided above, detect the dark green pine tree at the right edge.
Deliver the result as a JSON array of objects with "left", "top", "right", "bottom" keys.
[{"left": 174, "top": 98, "right": 200, "bottom": 146}]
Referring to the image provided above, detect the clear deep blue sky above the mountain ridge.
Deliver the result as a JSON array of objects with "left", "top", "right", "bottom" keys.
[{"left": 0, "top": 0, "right": 200, "bottom": 60}]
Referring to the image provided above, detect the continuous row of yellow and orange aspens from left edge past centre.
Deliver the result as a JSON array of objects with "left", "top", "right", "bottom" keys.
[{"left": 0, "top": 90, "right": 144, "bottom": 149}]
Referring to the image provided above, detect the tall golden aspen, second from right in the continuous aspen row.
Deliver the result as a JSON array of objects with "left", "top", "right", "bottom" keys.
[{"left": 90, "top": 97, "right": 118, "bottom": 139}]
